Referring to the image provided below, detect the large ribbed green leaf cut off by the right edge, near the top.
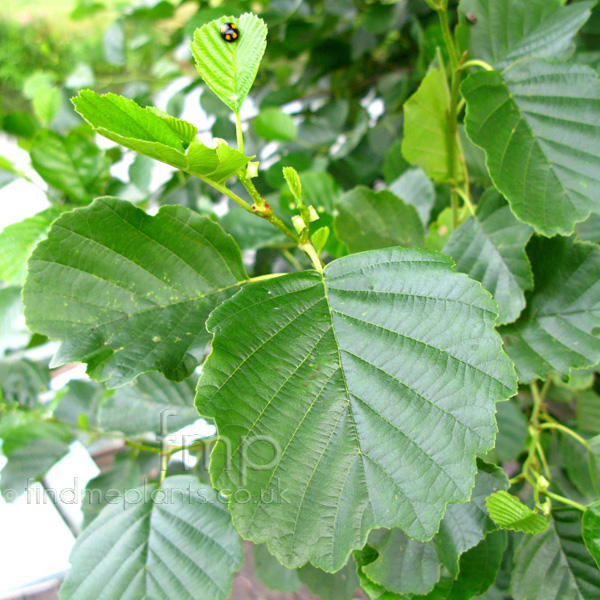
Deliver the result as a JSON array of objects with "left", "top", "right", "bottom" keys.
[{"left": 462, "top": 59, "right": 600, "bottom": 236}]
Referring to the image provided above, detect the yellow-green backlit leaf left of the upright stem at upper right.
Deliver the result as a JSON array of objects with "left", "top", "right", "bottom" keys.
[{"left": 402, "top": 69, "right": 463, "bottom": 183}]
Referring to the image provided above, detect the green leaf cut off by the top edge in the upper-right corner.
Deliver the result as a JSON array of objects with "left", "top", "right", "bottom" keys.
[{"left": 460, "top": 0, "right": 595, "bottom": 69}]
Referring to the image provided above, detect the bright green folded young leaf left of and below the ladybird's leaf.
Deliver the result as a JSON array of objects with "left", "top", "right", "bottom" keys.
[{"left": 72, "top": 90, "right": 250, "bottom": 183}]
